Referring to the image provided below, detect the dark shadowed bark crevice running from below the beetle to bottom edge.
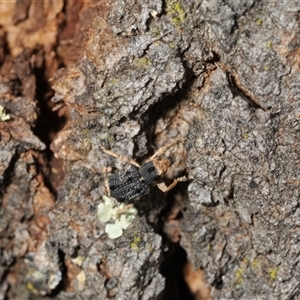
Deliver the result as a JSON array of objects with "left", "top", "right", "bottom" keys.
[{"left": 137, "top": 140, "right": 196, "bottom": 300}]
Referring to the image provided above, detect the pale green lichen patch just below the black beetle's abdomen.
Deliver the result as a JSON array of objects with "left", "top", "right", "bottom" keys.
[{"left": 97, "top": 196, "right": 137, "bottom": 239}]
